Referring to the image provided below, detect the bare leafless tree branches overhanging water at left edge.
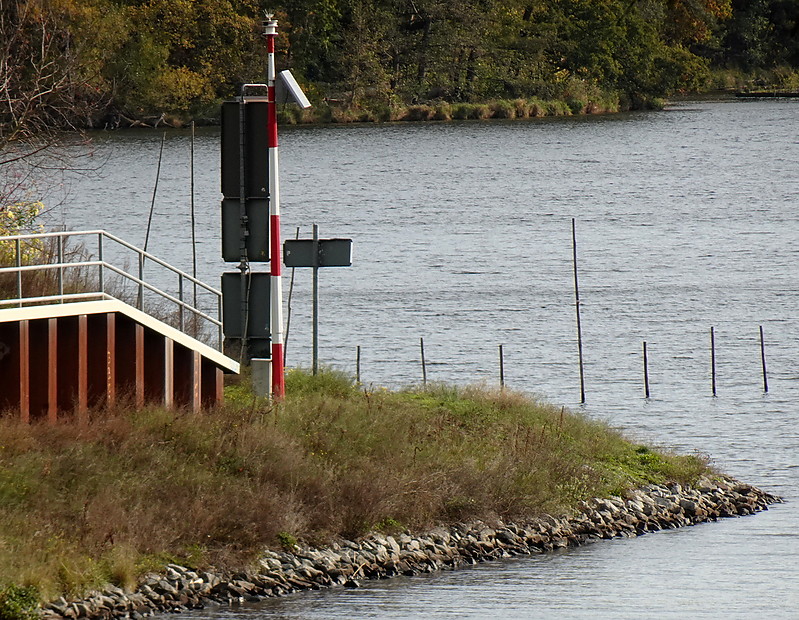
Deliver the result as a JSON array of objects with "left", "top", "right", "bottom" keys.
[{"left": 0, "top": 0, "right": 104, "bottom": 207}]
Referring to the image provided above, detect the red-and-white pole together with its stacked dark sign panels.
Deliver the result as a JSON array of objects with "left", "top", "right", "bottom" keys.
[{"left": 222, "top": 14, "right": 311, "bottom": 399}]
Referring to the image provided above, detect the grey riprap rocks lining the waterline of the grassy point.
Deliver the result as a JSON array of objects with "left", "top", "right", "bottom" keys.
[{"left": 42, "top": 478, "right": 782, "bottom": 618}]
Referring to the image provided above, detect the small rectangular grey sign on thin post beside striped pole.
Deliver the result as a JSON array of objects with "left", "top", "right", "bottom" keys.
[{"left": 283, "top": 224, "right": 352, "bottom": 375}]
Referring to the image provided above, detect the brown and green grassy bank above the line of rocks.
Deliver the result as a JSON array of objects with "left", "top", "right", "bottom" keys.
[{"left": 0, "top": 372, "right": 707, "bottom": 598}]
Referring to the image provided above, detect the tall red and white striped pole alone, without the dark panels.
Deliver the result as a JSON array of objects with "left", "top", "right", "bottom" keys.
[{"left": 264, "top": 15, "right": 286, "bottom": 399}]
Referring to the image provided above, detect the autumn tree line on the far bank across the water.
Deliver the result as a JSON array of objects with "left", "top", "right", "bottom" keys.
[{"left": 0, "top": 0, "right": 799, "bottom": 134}]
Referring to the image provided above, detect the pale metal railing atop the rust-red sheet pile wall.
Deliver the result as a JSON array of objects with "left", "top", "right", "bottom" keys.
[{"left": 0, "top": 230, "right": 223, "bottom": 351}]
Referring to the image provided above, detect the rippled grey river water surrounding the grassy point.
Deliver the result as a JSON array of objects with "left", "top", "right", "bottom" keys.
[{"left": 48, "top": 100, "right": 799, "bottom": 618}]
